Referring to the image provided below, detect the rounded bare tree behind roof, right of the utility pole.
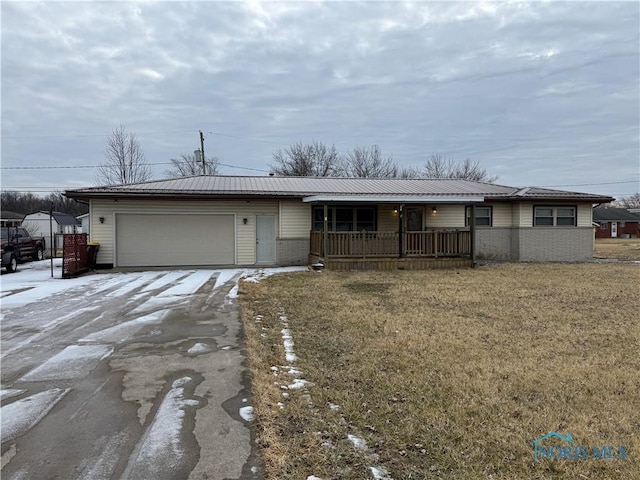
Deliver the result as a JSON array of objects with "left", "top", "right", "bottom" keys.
[{"left": 270, "top": 140, "right": 342, "bottom": 177}]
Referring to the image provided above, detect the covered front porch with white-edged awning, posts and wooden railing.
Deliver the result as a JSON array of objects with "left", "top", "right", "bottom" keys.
[{"left": 305, "top": 197, "right": 482, "bottom": 270}]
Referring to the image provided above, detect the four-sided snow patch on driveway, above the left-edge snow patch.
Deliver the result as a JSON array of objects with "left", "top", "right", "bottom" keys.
[{"left": 22, "top": 345, "right": 113, "bottom": 382}]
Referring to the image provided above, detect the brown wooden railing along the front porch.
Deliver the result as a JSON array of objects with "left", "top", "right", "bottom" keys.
[{"left": 310, "top": 230, "right": 471, "bottom": 258}]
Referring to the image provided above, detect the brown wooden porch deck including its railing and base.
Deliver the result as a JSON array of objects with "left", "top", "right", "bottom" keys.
[{"left": 309, "top": 229, "right": 473, "bottom": 270}]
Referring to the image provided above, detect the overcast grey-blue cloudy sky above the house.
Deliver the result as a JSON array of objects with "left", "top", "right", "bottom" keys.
[{"left": 0, "top": 1, "right": 640, "bottom": 197}]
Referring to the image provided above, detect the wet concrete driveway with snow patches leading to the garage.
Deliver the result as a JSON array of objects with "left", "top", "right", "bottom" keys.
[{"left": 1, "top": 261, "right": 298, "bottom": 480}]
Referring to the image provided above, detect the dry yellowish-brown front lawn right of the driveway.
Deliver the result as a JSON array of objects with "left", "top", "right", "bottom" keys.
[{"left": 240, "top": 264, "right": 640, "bottom": 480}]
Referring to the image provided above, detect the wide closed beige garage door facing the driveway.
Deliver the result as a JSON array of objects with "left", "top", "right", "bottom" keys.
[{"left": 116, "top": 213, "right": 235, "bottom": 267}]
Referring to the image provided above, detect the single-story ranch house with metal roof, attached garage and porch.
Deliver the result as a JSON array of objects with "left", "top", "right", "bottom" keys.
[{"left": 65, "top": 176, "right": 612, "bottom": 269}]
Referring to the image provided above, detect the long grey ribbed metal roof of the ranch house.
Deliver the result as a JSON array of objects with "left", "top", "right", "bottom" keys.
[{"left": 65, "top": 175, "right": 610, "bottom": 202}]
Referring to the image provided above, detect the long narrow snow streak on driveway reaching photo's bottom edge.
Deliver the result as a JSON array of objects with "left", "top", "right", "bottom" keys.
[{"left": 122, "top": 377, "right": 198, "bottom": 479}]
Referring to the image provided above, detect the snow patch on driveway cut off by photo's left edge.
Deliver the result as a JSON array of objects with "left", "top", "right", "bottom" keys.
[{"left": 0, "top": 388, "right": 69, "bottom": 443}]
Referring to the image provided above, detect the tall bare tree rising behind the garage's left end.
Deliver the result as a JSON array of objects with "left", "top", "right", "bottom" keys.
[{"left": 96, "top": 125, "right": 151, "bottom": 185}]
